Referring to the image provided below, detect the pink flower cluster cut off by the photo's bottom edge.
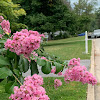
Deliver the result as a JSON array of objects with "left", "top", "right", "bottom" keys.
[{"left": 9, "top": 74, "right": 49, "bottom": 100}]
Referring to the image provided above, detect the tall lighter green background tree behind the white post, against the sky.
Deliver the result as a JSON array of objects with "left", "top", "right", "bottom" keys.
[{"left": 74, "top": 0, "right": 96, "bottom": 33}]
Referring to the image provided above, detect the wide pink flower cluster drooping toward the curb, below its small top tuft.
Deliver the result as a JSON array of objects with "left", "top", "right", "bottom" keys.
[{"left": 64, "top": 66, "right": 97, "bottom": 85}]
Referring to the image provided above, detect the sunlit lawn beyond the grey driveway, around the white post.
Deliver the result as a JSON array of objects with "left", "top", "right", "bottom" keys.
[{"left": 44, "top": 36, "right": 91, "bottom": 60}]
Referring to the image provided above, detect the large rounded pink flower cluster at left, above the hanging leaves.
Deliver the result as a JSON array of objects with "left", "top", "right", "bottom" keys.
[{"left": 5, "top": 29, "right": 41, "bottom": 57}]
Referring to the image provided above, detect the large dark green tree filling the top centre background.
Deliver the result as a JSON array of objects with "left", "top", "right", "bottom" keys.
[{"left": 20, "top": 0, "right": 75, "bottom": 33}]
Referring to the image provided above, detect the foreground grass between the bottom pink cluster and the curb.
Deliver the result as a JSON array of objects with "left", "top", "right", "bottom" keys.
[{"left": 44, "top": 77, "right": 87, "bottom": 100}]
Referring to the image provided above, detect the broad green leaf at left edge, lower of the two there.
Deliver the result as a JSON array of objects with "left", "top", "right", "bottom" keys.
[{"left": 0, "top": 67, "right": 13, "bottom": 79}]
